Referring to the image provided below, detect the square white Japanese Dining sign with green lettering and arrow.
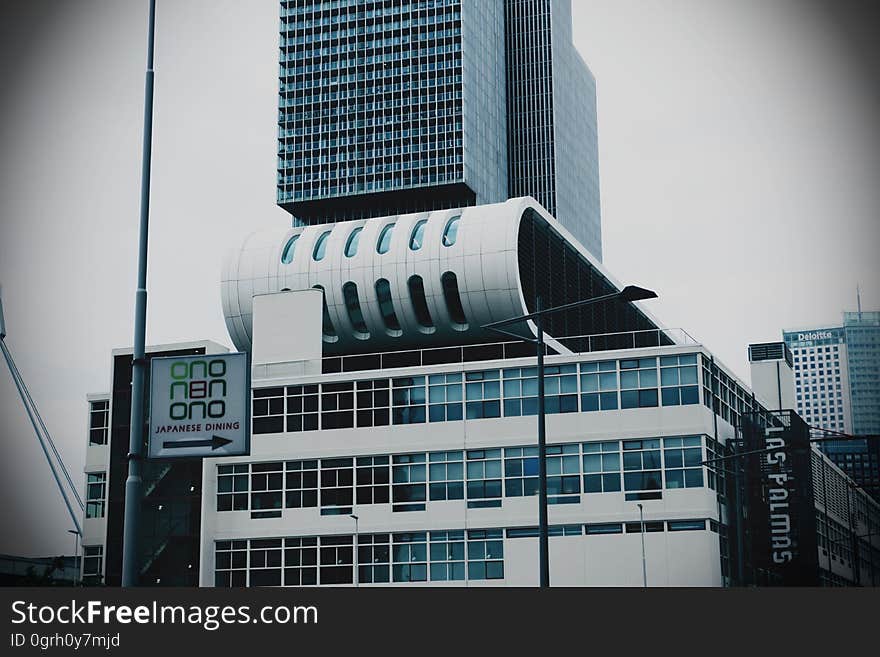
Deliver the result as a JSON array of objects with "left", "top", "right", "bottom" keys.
[{"left": 149, "top": 353, "right": 251, "bottom": 459}]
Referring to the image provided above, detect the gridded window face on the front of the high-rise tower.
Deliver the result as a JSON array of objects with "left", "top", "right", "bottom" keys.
[{"left": 278, "top": 0, "right": 464, "bottom": 204}]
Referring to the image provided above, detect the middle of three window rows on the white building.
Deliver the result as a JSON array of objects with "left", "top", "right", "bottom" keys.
[{"left": 217, "top": 436, "right": 718, "bottom": 517}]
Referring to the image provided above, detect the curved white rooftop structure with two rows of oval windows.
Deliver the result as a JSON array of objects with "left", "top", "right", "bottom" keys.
[{"left": 222, "top": 197, "right": 653, "bottom": 354}]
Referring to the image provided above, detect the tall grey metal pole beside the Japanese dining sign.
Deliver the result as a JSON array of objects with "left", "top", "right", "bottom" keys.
[{"left": 122, "top": 0, "right": 156, "bottom": 586}]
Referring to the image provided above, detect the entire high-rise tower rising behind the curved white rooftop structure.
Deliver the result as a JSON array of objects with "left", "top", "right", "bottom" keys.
[{"left": 277, "top": 0, "right": 601, "bottom": 258}]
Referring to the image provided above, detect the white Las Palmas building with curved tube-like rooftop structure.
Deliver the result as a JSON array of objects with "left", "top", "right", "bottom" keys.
[{"left": 84, "top": 198, "right": 880, "bottom": 586}]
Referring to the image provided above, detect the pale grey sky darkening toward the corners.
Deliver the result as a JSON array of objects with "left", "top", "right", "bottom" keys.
[{"left": 0, "top": 0, "right": 880, "bottom": 555}]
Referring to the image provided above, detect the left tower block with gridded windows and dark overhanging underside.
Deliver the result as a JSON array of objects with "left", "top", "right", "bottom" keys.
[{"left": 278, "top": 0, "right": 507, "bottom": 224}]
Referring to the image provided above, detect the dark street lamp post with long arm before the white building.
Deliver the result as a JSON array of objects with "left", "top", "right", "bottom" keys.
[{"left": 482, "top": 285, "right": 657, "bottom": 588}]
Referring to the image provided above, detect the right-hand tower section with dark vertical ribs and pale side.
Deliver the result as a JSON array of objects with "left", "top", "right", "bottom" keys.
[{"left": 504, "top": 0, "right": 602, "bottom": 260}]
